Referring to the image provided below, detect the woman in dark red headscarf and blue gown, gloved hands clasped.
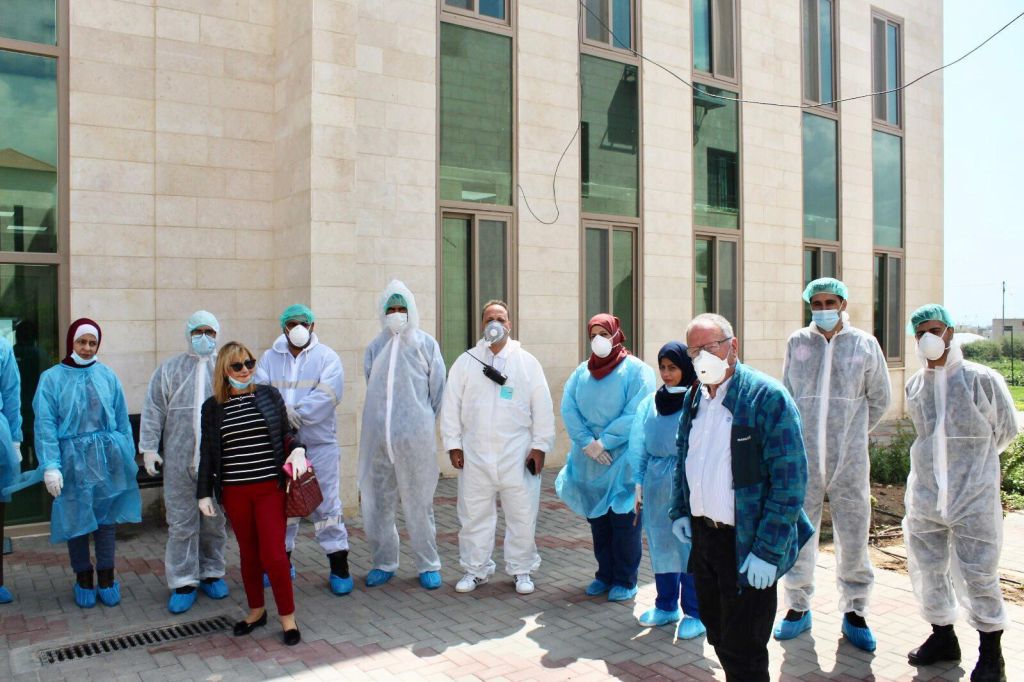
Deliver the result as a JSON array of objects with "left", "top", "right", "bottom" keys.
[{"left": 555, "top": 313, "right": 654, "bottom": 601}]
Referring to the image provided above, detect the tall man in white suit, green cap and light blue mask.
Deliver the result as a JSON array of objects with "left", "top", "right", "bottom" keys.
[{"left": 773, "top": 278, "right": 892, "bottom": 651}]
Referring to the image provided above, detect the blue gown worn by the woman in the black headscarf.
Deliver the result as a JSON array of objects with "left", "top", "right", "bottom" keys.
[{"left": 629, "top": 393, "right": 692, "bottom": 573}]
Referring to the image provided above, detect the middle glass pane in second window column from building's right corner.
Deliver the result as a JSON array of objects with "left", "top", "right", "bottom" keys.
[{"left": 804, "top": 114, "right": 839, "bottom": 242}]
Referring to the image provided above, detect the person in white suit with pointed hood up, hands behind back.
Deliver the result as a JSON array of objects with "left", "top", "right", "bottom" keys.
[{"left": 359, "top": 280, "right": 444, "bottom": 590}]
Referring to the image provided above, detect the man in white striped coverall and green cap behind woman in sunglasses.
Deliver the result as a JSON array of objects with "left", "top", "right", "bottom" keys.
[{"left": 256, "top": 303, "right": 352, "bottom": 595}]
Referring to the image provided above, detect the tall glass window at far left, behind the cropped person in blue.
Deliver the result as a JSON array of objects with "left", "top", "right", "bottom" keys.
[{"left": 0, "top": 0, "right": 68, "bottom": 523}]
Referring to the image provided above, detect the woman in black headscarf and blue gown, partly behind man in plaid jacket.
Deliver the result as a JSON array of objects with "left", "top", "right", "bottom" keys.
[{"left": 629, "top": 341, "right": 706, "bottom": 639}]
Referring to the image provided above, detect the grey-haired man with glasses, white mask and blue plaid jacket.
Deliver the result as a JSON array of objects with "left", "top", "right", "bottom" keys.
[{"left": 669, "top": 313, "right": 814, "bottom": 682}]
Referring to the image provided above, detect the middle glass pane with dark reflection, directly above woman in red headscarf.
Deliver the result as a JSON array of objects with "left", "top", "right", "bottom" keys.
[{"left": 580, "top": 54, "right": 640, "bottom": 216}]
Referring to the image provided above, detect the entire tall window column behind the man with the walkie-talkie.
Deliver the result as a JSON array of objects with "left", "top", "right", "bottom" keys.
[{"left": 438, "top": 9, "right": 515, "bottom": 366}]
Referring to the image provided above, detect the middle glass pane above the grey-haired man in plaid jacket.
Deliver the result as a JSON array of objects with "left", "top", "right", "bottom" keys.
[{"left": 693, "top": 84, "right": 739, "bottom": 229}]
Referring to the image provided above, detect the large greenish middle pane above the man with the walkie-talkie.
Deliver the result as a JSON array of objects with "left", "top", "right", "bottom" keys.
[{"left": 440, "top": 24, "right": 512, "bottom": 206}]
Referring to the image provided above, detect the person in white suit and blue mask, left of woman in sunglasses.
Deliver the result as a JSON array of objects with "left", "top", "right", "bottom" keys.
[{"left": 138, "top": 310, "right": 228, "bottom": 613}]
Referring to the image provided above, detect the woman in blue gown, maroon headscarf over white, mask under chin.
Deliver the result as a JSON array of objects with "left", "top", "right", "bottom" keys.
[{"left": 32, "top": 317, "right": 142, "bottom": 608}]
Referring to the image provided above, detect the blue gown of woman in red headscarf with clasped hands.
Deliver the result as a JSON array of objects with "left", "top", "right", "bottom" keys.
[{"left": 555, "top": 355, "right": 654, "bottom": 518}]
